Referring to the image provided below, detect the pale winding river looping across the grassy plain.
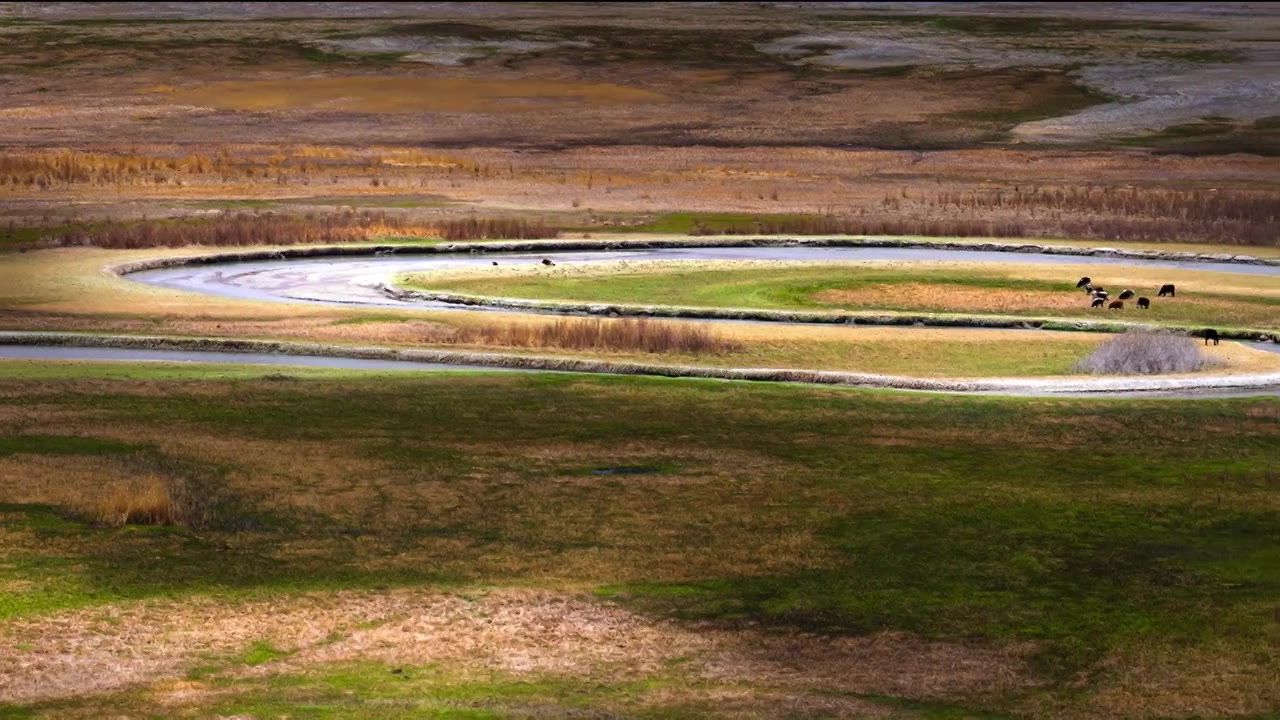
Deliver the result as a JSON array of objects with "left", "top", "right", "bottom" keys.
[{"left": 0, "top": 245, "right": 1280, "bottom": 397}]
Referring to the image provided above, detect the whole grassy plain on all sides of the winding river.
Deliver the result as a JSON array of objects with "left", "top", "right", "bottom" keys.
[{"left": 0, "top": 3, "right": 1280, "bottom": 720}]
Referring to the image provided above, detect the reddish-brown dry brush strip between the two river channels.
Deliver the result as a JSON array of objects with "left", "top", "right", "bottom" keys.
[{"left": 454, "top": 318, "right": 741, "bottom": 354}]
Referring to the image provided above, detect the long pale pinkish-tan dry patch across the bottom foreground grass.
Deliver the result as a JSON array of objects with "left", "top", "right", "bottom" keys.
[{"left": 0, "top": 589, "right": 1033, "bottom": 702}]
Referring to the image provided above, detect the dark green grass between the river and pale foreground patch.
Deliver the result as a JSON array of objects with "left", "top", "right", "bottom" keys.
[{"left": 0, "top": 370, "right": 1280, "bottom": 678}]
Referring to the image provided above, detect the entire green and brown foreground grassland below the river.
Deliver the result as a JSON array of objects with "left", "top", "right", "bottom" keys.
[{"left": 0, "top": 363, "right": 1280, "bottom": 717}]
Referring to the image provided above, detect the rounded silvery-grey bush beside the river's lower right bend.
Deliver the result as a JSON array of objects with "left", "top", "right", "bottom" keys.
[{"left": 1075, "top": 331, "right": 1221, "bottom": 375}]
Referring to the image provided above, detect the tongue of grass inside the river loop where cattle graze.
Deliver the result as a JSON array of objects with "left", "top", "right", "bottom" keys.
[{"left": 407, "top": 260, "right": 1280, "bottom": 329}]
